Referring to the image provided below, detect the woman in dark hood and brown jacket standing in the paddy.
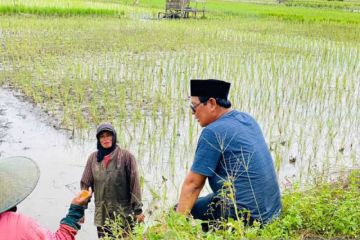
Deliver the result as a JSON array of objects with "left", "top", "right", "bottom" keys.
[{"left": 80, "top": 123, "right": 144, "bottom": 238}]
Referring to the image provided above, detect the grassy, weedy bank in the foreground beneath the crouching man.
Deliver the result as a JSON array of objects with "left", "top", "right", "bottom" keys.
[{"left": 104, "top": 171, "right": 360, "bottom": 240}]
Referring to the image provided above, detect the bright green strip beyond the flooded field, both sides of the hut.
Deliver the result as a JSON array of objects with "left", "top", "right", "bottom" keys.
[{"left": 0, "top": 0, "right": 360, "bottom": 24}]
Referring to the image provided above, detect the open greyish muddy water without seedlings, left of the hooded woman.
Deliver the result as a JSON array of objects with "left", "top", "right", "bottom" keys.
[{"left": 0, "top": 89, "right": 97, "bottom": 240}]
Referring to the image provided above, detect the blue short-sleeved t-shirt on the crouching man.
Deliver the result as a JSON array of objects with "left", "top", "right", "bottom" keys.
[{"left": 191, "top": 110, "right": 281, "bottom": 222}]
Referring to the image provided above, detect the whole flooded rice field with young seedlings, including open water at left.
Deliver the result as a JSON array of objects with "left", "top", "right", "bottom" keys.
[{"left": 0, "top": 17, "right": 360, "bottom": 240}]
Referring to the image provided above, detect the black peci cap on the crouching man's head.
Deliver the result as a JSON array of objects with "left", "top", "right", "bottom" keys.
[{"left": 190, "top": 79, "right": 230, "bottom": 99}]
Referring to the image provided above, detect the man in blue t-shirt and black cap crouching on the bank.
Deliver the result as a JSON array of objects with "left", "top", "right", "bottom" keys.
[{"left": 176, "top": 79, "right": 281, "bottom": 228}]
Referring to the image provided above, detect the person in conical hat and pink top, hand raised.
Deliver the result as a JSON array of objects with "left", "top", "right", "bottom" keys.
[{"left": 0, "top": 157, "right": 91, "bottom": 240}]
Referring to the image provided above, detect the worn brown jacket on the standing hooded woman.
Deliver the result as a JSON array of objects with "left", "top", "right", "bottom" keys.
[{"left": 80, "top": 146, "right": 142, "bottom": 226}]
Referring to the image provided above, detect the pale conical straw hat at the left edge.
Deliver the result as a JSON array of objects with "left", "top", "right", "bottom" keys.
[{"left": 0, "top": 157, "right": 40, "bottom": 213}]
